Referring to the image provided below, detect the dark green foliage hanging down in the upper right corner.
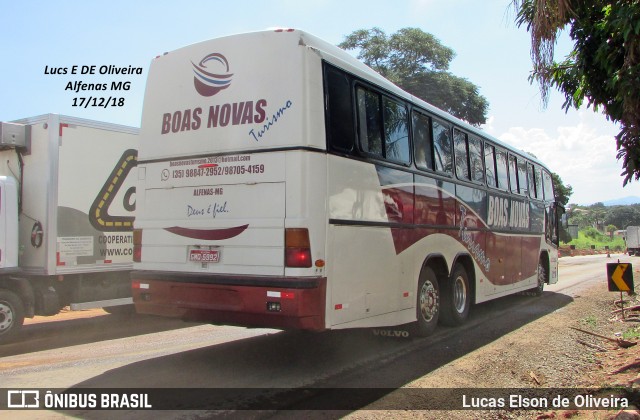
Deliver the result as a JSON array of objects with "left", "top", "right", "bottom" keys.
[{"left": 512, "top": 0, "right": 640, "bottom": 185}]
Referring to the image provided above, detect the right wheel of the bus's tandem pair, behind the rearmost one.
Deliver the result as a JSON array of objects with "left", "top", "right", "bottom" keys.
[{"left": 440, "top": 264, "right": 471, "bottom": 326}]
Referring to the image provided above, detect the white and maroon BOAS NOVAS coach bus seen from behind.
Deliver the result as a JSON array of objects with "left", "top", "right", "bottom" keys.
[{"left": 132, "top": 29, "right": 559, "bottom": 336}]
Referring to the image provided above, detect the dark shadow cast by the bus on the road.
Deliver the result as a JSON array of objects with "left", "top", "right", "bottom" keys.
[{"left": 55, "top": 292, "right": 573, "bottom": 419}]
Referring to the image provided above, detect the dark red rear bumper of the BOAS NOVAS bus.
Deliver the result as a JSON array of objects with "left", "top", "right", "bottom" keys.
[{"left": 132, "top": 271, "right": 327, "bottom": 331}]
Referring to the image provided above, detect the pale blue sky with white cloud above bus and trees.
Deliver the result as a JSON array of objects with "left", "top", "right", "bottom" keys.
[{"left": 0, "top": 0, "right": 640, "bottom": 205}]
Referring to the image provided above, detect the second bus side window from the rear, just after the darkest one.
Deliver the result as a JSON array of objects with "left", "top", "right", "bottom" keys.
[{"left": 357, "top": 87, "right": 383, "bottom": 157}]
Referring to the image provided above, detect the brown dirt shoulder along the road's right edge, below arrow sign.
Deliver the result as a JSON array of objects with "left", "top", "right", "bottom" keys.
[{"left": 349, "top": 273, "right": 640, "bottom": 419}]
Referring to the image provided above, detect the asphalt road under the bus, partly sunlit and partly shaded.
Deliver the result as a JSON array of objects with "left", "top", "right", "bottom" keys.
[{"left": 0, "top": 251, "right": 640, "bottom": 419}]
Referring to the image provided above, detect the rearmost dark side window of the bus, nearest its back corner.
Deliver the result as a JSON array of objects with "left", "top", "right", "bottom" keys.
[{"left": 325, "top": 65, "right": 355, "bottom": 152}]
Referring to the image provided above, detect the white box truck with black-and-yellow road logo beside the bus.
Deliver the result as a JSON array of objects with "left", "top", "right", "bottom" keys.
[{"left": 0, "top": 114, "right": 138, "bottom": 343}]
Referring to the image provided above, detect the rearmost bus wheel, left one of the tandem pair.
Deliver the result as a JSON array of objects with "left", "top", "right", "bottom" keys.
[{"left": 411, "top": 267, "right": 440, "bottom": 337}]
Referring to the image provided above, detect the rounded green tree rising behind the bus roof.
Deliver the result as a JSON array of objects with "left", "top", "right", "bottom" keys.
[{"left": 338, "top": 28, "right": 489, "bottom": 126}]
